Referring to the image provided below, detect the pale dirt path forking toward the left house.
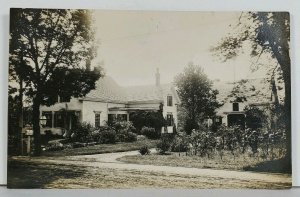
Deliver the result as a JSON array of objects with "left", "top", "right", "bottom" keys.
[{"left": 11, "top": 150, "right": 291, "bottom": 187}]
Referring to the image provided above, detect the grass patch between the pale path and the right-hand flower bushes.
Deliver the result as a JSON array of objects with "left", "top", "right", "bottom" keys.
[{"left": 118, "top": 152, "right": 287, "bottom": 173}]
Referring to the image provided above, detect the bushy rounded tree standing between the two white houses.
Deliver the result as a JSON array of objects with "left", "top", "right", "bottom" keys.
[{"left": 175, "top": 64, "right": 220, "bottom": 133}]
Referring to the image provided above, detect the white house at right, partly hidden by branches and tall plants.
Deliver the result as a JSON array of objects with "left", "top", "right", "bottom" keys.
[{"left": 211, "top": 78, "right": 284, "bottom": 126}]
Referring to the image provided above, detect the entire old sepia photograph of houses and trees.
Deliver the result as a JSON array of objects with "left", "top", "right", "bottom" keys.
[{"left": 7, "top": 8, "right": 292, "bottom": 189}]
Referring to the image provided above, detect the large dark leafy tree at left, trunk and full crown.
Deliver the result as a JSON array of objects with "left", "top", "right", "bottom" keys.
[{"left": 9, "top": 9, "right": 101, "bottom": 155}]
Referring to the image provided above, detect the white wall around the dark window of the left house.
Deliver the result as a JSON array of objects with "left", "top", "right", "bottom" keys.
[{"left": 82, "top": 101, "right": 127, "bottom": 126}]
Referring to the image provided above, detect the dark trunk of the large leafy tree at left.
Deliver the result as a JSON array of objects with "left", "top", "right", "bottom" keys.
[{"left": 32, "top": 93, "right": 41, "bottom": 156}]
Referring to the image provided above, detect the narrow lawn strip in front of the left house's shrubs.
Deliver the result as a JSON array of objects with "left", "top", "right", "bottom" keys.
[{"left": 43, "top": 139, "right": 158, "bottom": 156}]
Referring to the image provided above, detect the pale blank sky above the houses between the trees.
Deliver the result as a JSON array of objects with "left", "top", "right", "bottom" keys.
[{"left": 93, "top": 11, "right": 268, "bottom": 86}]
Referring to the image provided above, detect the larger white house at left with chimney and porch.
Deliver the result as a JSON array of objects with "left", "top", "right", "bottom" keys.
[{"left": 40, "top": 70, "right": 180, "bottom": 135}]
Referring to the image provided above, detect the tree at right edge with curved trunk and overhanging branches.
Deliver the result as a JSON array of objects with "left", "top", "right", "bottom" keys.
[{"left": 212, "top": 12, "right": 291, "bottom": 167}]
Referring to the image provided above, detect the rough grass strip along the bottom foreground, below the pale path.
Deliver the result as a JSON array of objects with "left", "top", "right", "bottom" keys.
[{"left": 8, "top": 159, "right": 291, "bottom": 189}]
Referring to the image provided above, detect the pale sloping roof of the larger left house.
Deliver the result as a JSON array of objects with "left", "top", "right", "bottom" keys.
[{"left": 84, "top": 76, "right": 179, "bottom": 103}]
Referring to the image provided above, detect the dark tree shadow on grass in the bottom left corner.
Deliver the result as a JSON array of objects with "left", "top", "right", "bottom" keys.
[{"left": 7, "top": 160, "right": 86, "bottom": 189}]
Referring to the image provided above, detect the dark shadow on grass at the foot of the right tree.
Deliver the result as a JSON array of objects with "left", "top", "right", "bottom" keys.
[{"left": 243, "top": 158, "right": 292, "bottom": 174}]
